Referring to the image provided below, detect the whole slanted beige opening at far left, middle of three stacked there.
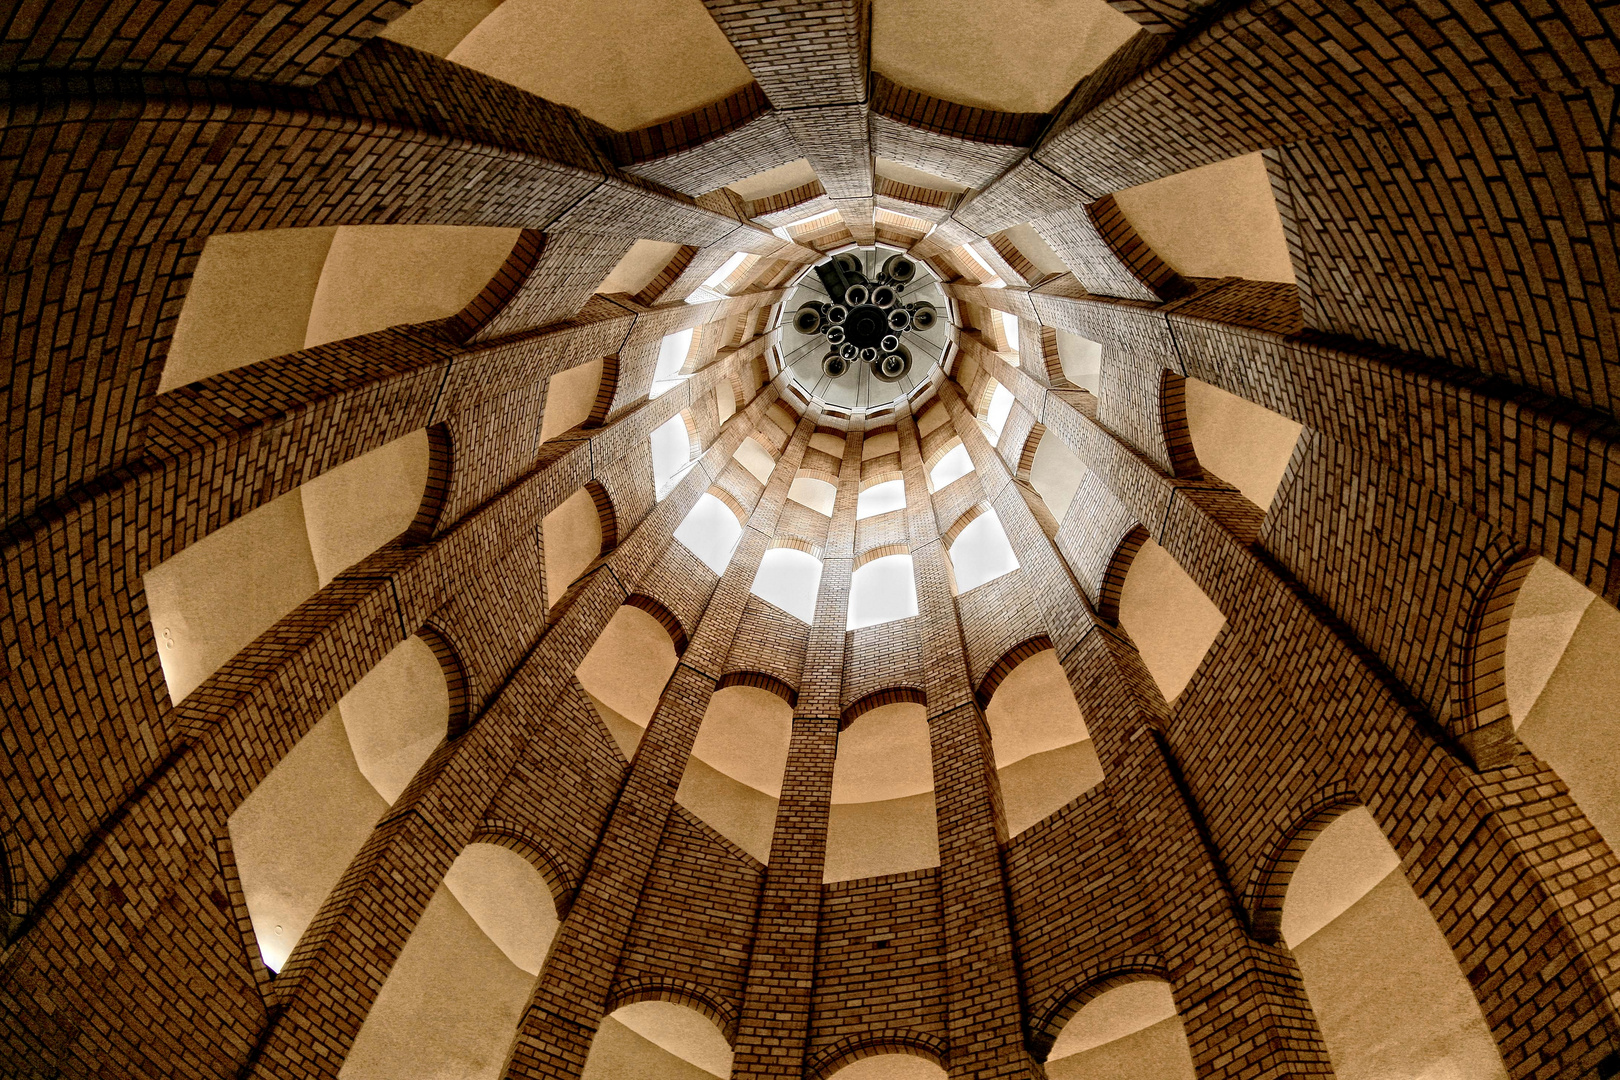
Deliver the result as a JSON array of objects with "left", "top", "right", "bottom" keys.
[{"left": 143, "top": 431, "right": 431, "bottom": 704}]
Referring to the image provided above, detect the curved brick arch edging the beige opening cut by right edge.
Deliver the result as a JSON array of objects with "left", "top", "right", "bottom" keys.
[{"left": 1445, "top": 549, "right": 1537, "bottom": 769}]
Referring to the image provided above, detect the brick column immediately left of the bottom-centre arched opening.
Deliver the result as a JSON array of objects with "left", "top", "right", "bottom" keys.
[{"left": 731, "top": 431, "right": 863, "bottom": 1080}]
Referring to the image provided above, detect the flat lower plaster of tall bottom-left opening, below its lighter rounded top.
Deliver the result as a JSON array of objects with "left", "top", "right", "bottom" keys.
[{"left": 339, "top": 887, "right": 534, "bottom": 1080}]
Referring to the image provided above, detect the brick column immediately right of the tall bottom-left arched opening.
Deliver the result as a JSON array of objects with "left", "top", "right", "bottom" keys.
[{"left": 505, "top": 416, "right": 813, "bottom": 1080}]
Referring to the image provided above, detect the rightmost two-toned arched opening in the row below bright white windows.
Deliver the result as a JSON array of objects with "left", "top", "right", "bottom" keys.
[{"left": 985, "top": 649, "right": 1103, "bottom": 837}]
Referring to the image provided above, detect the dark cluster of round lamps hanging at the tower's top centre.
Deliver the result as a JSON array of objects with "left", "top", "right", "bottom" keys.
[{"left": 794, "top": 251, "right": 940, "bottom": 382}]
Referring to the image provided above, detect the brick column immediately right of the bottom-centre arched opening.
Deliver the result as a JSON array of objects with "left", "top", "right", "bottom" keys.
[{"left": 897, "top": 411, "right": 1040, "bottom": 1078}]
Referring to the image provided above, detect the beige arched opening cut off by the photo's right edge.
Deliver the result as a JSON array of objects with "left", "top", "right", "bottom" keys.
[{"left": 1503, "top": 559, "right": 1620, "bottom": 847}]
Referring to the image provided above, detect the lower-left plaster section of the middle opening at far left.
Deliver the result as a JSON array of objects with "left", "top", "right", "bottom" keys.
[{"left": 143, "top": 491, "right": 319, "bottom": 704}]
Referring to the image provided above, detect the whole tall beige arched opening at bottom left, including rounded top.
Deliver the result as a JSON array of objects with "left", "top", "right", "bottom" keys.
[{"left": 339, "top": 844, "right": 557, "bottom": 1080}]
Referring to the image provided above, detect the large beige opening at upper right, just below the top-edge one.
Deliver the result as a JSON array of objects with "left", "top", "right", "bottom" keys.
[{"left": 1115, "top": 154, "right": 1294, "bottom": 282}]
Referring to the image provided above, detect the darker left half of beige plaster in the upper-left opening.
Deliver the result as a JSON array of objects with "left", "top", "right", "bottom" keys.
[{"left": 157, "top": 228, "right": 337, "bottom": 393}]
